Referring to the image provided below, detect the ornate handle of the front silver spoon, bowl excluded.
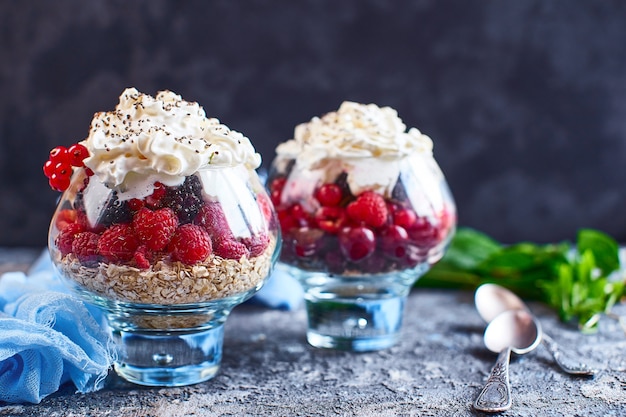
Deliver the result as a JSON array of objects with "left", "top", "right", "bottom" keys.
[{"left": 474, "top": 347, "right": 511, "bottom": 413}]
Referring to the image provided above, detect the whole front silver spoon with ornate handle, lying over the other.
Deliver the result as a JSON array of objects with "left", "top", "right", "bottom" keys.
[{"left": 474, "top": 310, "right": 541, "bottom": 413}]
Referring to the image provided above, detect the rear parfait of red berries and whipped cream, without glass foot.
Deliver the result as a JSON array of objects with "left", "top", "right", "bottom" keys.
[{"left": 267, "top": 102, "right": 456, "bottom": 276}]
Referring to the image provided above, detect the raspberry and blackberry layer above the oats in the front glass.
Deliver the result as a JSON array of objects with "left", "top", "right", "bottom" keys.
[{"left": 54, "top": 175, "right": 272, "bottom": 269}]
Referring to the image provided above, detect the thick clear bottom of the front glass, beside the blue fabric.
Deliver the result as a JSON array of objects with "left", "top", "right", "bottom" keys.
[{"left": 112, "top": 325, "right": 224, "bottom": 387}]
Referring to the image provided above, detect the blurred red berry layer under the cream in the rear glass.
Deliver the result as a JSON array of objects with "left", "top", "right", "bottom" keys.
[{"left": 268, "top": 173, "right": 454, "bottom": 275}]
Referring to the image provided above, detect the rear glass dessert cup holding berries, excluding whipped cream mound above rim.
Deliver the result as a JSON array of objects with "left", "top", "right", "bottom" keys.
[{"left": 267, "top": 153, "right": 456, "bottom": 351}]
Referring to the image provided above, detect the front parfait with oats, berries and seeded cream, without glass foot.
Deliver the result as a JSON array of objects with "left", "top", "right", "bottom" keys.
[{"left": 44, "top": 88, "right": 278, "bottom": 305}]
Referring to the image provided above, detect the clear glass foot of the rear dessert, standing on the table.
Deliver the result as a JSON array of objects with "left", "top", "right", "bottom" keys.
[{"left": 306, "top": 294, "right": 406, "bottom": 352}]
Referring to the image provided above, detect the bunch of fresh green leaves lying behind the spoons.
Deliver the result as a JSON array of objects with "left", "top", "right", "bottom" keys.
[{"left": 416, "top": 224, "right": 626, "bottom": 332}]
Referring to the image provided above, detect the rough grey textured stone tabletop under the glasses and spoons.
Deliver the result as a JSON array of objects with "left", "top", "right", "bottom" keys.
[{"left": 0, "top": 249, "right": 626, "bottom": 417}]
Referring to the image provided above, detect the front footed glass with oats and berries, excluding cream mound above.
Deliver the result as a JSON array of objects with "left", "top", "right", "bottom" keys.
[{"left": 49, "top": 165, "right": 281, "bottom": 386}]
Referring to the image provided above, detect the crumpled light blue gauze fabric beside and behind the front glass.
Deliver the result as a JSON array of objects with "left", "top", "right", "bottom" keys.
[{"left": 0, "top": 251, "right": 303, "bottom": 403}]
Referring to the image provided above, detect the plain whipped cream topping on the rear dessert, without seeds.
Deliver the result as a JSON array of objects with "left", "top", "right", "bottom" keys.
[{"left": 276, "top": 101, "right": 433, "bottom": 195}]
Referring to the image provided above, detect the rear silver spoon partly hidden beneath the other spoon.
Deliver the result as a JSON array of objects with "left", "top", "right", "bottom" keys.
[{"left": 474, "top": 284, "right": 596, "bottom": 376}]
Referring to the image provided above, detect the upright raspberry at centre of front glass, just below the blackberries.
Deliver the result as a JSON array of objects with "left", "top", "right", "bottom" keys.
[{"left": 132, "top": 207, "right": 178, "bottom": 251}]
